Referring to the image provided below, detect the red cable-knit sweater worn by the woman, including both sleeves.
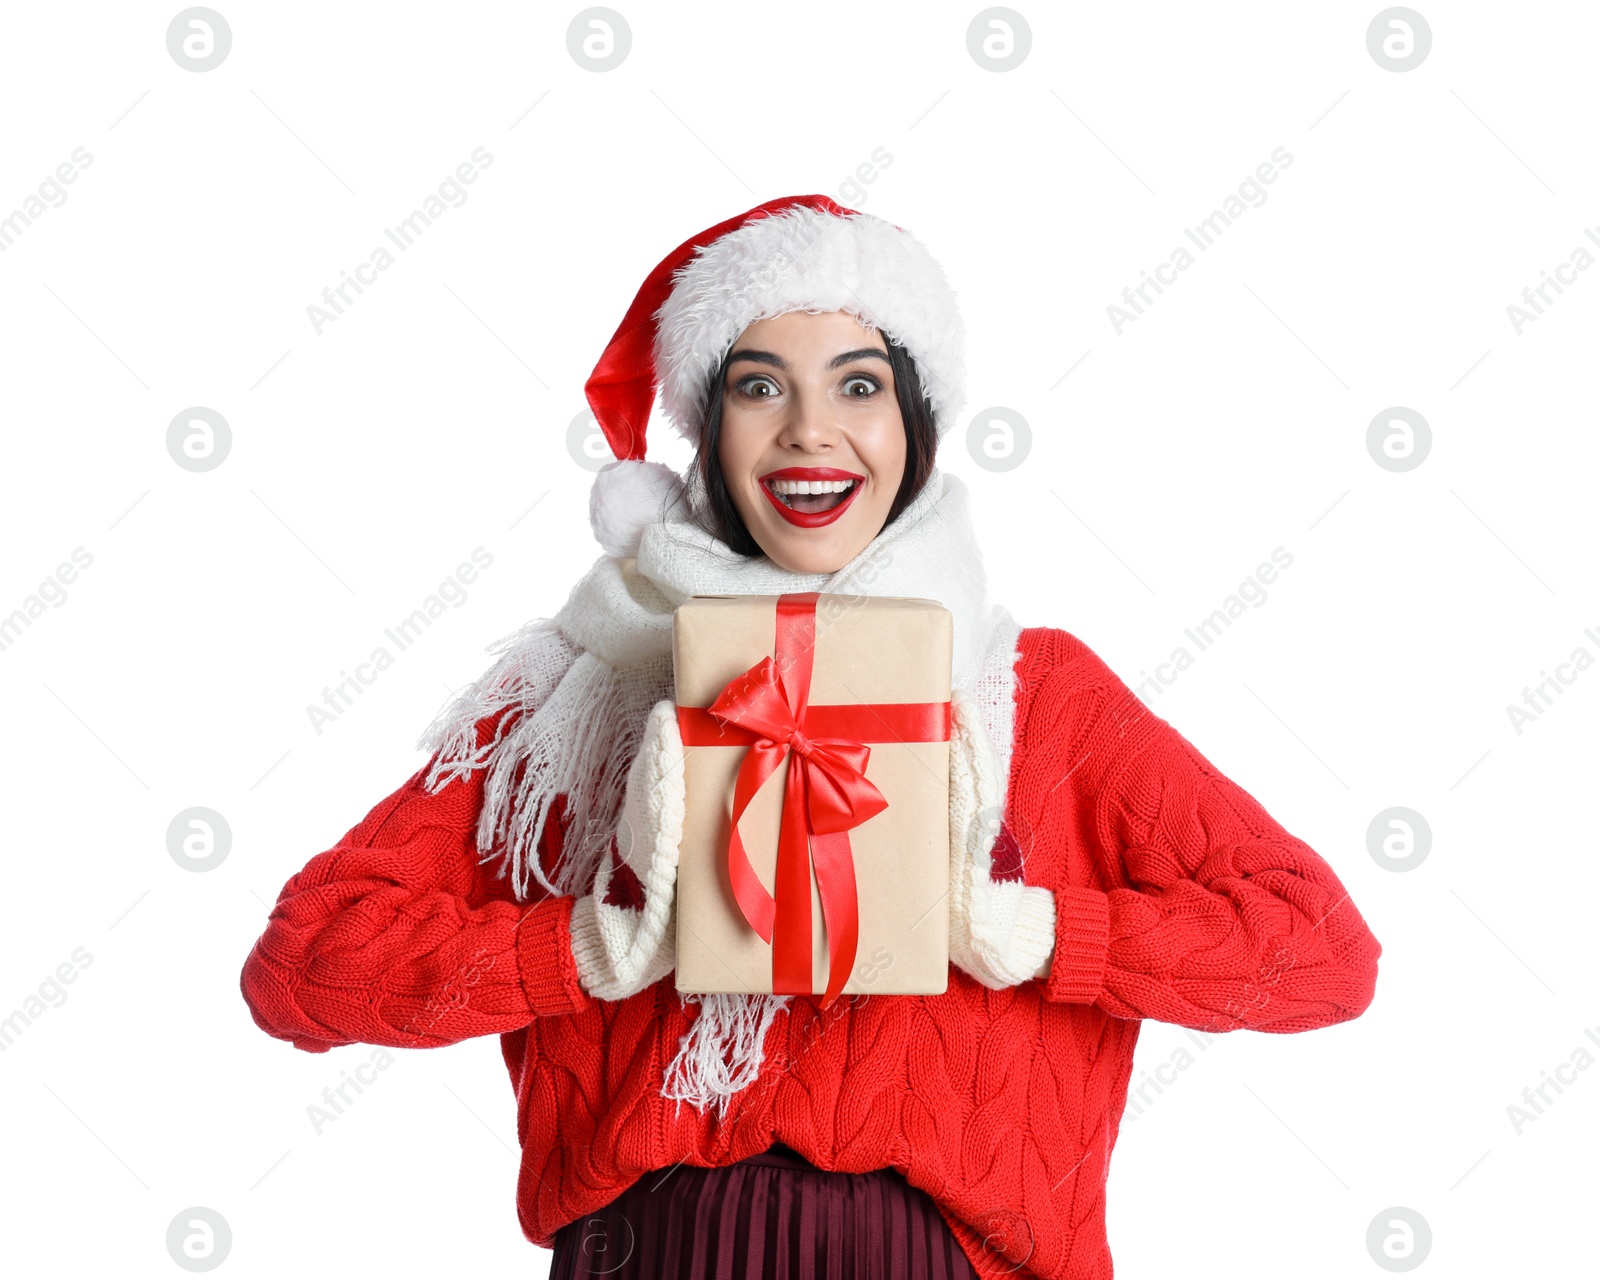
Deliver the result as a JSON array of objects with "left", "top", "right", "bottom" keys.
[{"left": 242, "top": 629, "right": 1381, "bottom": 1280}]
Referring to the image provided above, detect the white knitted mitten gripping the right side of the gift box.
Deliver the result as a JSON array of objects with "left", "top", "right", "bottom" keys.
[{"left": 950, "top": 691, "right": 1056, "bottom": 990}]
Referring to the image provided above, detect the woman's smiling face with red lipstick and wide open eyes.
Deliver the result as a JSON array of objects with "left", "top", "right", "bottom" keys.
[{"left": 717, "top": 310, "right": 906, "bottom": 573}]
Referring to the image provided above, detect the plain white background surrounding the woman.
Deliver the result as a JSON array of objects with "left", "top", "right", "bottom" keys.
[{"left": 0, "top": 0, "right": 1600, "bottom": 1277}]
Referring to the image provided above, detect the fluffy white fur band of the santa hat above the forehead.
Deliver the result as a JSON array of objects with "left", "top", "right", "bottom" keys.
[{"left": 654, "top": 205, "right": 966, "bottom": 442}]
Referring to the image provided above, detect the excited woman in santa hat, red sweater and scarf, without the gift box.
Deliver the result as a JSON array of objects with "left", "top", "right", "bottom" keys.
[{"left": 242, "top": 197, "right": 1379, "bottom": 1280}]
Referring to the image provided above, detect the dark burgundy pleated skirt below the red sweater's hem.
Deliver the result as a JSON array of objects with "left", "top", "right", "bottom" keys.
[{"left": 550, "top": 1142, "right": 978, "bottom": 1280}]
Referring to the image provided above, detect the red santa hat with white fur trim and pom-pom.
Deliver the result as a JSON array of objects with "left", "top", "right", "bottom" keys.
[{"left": 584, "top": 195, "right": 966, "bottom": 557}]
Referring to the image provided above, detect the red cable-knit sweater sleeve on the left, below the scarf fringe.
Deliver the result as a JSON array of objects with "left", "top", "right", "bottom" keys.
[{"left": 240, "top": 713, "right": 590, "bottom": 1053}]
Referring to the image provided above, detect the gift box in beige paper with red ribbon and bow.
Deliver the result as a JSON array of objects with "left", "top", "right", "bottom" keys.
[{"left": 672, "top": 592, "right": 950, "bottom": 1008}]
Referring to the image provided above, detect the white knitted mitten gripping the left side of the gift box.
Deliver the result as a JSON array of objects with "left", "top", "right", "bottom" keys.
[{"left": 571, "top": 699, "right": 683, "bottom": 1000}]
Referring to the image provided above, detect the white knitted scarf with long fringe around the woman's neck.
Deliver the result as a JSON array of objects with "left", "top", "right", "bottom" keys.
[{"left": 419, "top": 470, "right": 1019, "bottom": 1110}]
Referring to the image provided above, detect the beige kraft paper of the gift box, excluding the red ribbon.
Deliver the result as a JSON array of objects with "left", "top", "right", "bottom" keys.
[{"left": 672, "top": 594, "right": 950, "bottom": 995}]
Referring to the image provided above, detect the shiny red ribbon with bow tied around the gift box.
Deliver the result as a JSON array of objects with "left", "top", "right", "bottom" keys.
[{"left": 678, "top": 590, "right": 950, "bottom": 1010}]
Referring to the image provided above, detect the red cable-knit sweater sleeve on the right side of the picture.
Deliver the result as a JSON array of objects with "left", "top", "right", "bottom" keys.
[{"left": 1029, "top": 642, "right": 1382, "bottom": 1032}]
